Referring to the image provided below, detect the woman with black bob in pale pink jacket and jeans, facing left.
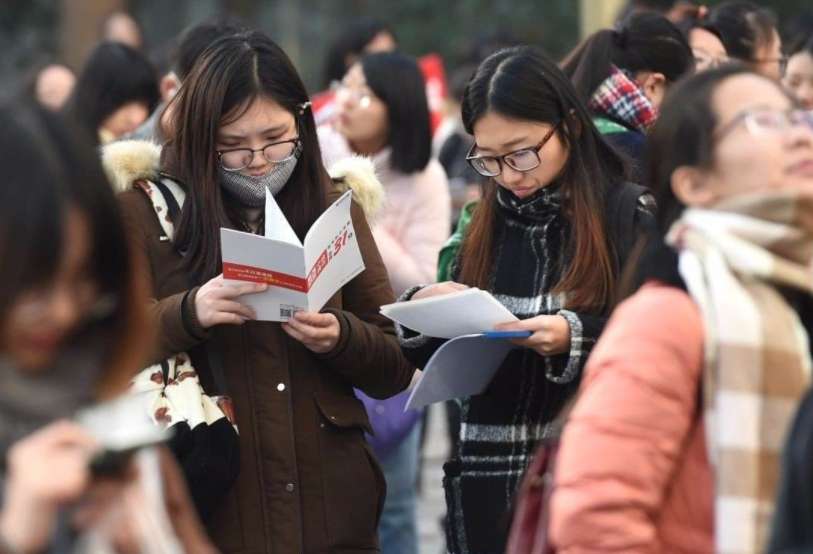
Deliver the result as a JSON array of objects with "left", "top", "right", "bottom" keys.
[{"left": 319, "top": 53, "right": 451, "bottom": 554}]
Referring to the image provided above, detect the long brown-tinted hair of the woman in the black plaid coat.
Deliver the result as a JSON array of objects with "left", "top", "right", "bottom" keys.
[{"left": 460, "top": 46, "right": 627, "bottom": 313}]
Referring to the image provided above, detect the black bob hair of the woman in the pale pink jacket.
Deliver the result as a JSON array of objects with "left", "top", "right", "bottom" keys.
[{"left": 359, "top": 52, "right": 432, "bottom": 173}]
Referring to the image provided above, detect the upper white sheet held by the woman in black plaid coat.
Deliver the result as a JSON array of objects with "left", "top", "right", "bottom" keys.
[{"left": 381, "top": 288, "right": 519, "bottom": 339}]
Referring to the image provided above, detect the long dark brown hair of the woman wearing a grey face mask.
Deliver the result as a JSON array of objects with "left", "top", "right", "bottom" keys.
[{"left": 162, "top": 31, "right": 329, "bottom": 280}]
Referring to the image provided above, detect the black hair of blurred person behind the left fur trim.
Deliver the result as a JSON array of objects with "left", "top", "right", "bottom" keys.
[{"left": 66, "top": 42, "right": 161, "bottom": 140}]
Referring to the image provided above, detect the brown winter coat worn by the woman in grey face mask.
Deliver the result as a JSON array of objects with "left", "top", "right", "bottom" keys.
[{"left": 107, "top": 140, "right": 413, "bottom": 554}]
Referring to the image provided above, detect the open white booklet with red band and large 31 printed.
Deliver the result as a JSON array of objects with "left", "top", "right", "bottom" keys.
[{"left": 220, "top": 191, "right": 364, "bottom": 321}]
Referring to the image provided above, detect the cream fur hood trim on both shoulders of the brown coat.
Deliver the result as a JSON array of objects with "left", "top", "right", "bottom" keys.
[{"left": 102, "top": 140, "right": 384, "bottom": 220}]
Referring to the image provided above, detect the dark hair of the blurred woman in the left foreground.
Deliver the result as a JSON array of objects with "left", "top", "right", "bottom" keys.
[{"left": 0, "top": 102, "right": 149, "bottom": 392}]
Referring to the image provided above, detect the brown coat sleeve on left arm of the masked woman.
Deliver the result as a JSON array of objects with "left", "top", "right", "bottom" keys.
[{"left": 119, "top": 190, "right": 207, "bottom": 364}]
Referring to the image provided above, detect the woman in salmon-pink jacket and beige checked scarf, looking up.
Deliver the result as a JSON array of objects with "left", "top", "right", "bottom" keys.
[{"left": 549, "top": 68, "right": 813, "bottom": 554}]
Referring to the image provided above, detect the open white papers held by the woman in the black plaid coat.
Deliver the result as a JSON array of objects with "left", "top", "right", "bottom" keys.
[{"left": 381, "top": 288, "right": 530, "bottom": 410}]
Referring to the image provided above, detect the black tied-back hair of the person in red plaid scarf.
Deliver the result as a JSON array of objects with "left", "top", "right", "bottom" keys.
[{"left": 562, "top": 12, "right": 694, "bottom": 104}]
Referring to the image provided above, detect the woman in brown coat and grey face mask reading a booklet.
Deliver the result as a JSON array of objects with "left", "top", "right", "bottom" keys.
[{"left": 109, "top": 32, "right": 414, "bottom": 554}]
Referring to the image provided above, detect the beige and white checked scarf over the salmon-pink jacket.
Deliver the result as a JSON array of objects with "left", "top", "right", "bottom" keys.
[{"left": 667, "top": 193, "right": 813, "bottom": 554}]
